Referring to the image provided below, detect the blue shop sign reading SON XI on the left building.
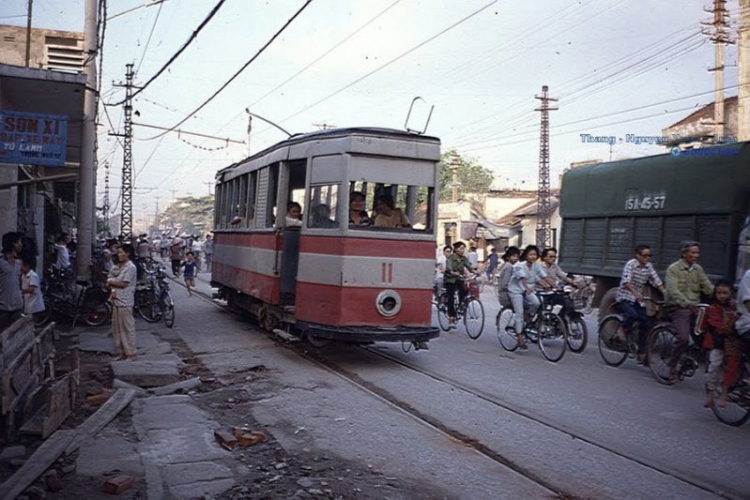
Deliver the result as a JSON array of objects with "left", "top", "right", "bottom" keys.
[{"left": 0, "top": 110, "right": 68, "bottom": 166}]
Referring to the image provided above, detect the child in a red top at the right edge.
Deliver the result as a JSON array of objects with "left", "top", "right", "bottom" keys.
[{"left": 702, "top": 280, "right": 739, "bottom": 408}]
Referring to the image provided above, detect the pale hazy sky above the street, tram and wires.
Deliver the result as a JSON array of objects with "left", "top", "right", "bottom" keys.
[{"left": 0, "top": 0, "right": 738, "bottom": 228}]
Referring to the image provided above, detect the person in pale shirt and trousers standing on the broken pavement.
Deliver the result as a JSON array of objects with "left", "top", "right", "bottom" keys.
[{"left": 107, "top": 243, "right": 138, "bottom": 361}]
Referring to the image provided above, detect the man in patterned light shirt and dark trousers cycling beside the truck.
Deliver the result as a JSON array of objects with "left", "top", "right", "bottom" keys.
[{"left": 616, "top": 245, "right": 666, "bottom": 364}]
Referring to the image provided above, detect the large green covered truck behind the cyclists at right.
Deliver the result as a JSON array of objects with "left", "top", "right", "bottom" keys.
[{"left": 560, "top": 142, "right": 750, "bottom": 311}]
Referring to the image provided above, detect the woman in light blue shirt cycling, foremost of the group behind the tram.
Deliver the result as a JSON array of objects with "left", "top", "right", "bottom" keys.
[{"left": 508, "top": 245, "right": 553, "bottom": 349}]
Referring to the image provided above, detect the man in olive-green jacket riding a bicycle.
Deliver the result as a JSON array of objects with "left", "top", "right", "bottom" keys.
[{"left": 666, "top": 241, "right": 714, "bottom": 384}]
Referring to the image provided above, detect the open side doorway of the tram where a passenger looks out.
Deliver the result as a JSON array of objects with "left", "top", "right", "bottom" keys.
[{"left": 278, "top": 160, "right": 307, "bottom": 306}]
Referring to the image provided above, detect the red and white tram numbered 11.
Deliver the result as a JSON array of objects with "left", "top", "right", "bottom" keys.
[{"left": 212, "top": 128, "right": 440, "bottom": 342}]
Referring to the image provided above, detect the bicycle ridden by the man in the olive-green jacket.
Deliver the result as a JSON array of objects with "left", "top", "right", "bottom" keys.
[{"left": 647, "top": 302, "right": 709, "bottom": 384}]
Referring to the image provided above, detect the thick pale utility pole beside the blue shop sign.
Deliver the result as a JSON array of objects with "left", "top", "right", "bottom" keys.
[{"left": 76, "top": 0, "right": 99, "bottom": 280}]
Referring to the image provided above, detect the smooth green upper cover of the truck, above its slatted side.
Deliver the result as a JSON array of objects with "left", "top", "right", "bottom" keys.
[{"left": 560, "top": 142, "right": 750, "bottom": 217}]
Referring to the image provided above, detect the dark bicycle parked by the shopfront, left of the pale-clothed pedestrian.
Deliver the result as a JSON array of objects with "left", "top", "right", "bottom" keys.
[{"left": 35, "top": 266, "right": 112, "bottom": 327}]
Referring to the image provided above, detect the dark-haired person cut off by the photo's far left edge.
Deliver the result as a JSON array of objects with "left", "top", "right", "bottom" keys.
[{"left": 0, "top": 232, "right": 23, "bottom": 331}]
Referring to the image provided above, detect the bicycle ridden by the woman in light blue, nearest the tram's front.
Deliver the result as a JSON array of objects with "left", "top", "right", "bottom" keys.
[{"left": 495, "top": 291, "right": 568, "bottom": 363}]
